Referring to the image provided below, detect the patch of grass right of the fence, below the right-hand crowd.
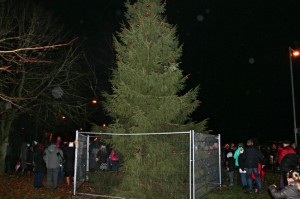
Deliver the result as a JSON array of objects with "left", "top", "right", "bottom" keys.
[{"left": 203, "top": 168, "right": 280, "bottom": 199}]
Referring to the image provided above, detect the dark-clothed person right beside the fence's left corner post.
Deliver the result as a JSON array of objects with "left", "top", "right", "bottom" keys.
[{"left": 64, "top": 142, "right": 75, "bottom": 186}]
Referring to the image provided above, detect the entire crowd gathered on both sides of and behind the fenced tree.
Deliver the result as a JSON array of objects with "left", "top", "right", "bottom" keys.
[{"left": 5, "top": 134, "right": 300, "bottom": 198}]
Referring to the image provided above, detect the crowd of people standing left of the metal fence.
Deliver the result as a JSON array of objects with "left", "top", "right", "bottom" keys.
[{"left": 5, "top": 136, "right": 75, "bottom": 189}]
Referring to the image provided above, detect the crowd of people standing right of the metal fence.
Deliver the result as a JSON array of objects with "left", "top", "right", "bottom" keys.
[{"left": 223, "top": 139, "right": 300, "bottom": 198}]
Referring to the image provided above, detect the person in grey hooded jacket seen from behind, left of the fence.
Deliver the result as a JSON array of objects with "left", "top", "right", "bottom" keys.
[{"left": 44, "top": 142, "right": 64, "bottom": 189}]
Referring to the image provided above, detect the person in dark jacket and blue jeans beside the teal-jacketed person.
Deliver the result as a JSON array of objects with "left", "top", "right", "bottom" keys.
[{"left": 242, "top": 139, "right": 264, "bottom": 193}]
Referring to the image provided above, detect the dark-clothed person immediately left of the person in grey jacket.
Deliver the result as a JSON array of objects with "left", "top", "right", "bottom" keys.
[{"left": 33, "top": 143, "right": 46, "bottom": 188}]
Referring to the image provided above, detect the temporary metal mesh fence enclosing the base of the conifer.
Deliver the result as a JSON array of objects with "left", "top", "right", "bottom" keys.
[{"left": 74, "top": 131, "right": 219, "bottom": 199}]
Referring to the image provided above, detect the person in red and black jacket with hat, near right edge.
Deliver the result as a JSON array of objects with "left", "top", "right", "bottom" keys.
[{"left": 278, "top": 140, "right": 298, "bottom": 188}]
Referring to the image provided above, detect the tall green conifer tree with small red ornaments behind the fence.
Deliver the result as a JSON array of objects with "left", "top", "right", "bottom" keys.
[{"left": 95, "top": 0, "right": 206, "bottom": 198}]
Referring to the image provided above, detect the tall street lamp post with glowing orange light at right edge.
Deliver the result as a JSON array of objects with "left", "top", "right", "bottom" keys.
[{"left": 289, "top": 47, "right": 300, "bottom": 146}]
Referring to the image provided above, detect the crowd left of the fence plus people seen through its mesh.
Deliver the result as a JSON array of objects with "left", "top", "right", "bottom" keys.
[{"left": 5, "top": 136, "right": 120, "bottom": 189}]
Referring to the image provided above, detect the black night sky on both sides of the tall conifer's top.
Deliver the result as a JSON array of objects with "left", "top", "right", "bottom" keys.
[{"left": 47, "top": 0, "right": 300, "bottom": 141}]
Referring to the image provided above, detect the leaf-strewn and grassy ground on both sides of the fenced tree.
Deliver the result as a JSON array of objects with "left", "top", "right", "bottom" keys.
[{"left": 0, "top": 171, "right": 280, "bottom": 199}]
